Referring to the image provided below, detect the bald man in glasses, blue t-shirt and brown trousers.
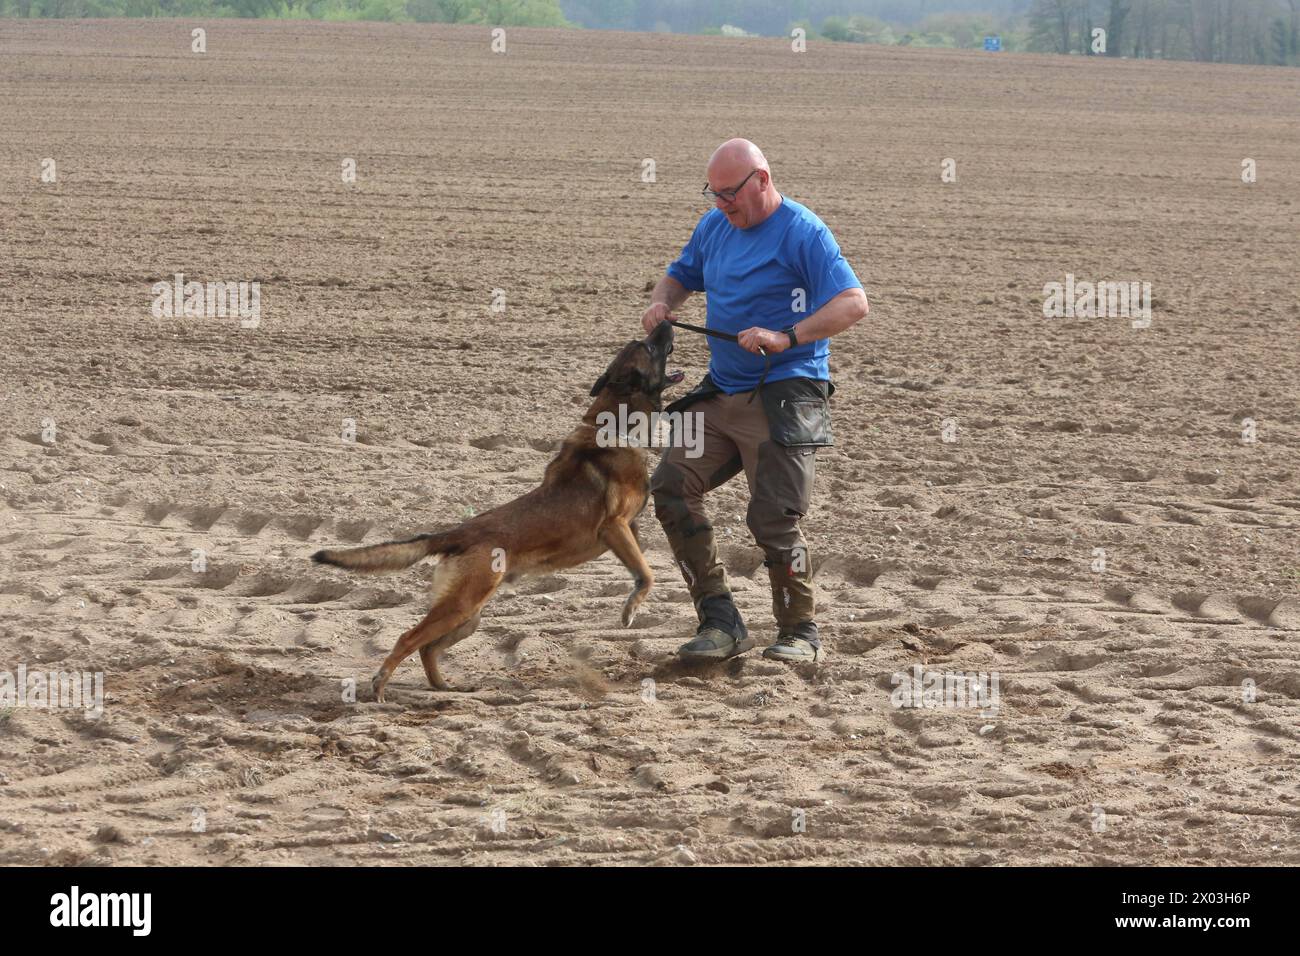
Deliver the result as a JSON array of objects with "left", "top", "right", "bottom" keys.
[{"left": 641, "top": 139, "right": 868, "bottom": 662}]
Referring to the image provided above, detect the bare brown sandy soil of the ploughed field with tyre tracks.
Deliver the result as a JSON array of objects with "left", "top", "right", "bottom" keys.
[{"left": 0, "top": 21, "right": 1300, "bottom": 865}]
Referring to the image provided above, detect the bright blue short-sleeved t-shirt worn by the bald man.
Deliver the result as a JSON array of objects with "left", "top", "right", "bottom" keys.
[{"left": 668, "top": 196, "right": 862, "bottom": 394}]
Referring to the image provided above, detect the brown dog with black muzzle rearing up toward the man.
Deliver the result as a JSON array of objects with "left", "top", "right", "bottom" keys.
[{"left": 312, "top": 323, "right": 683, "bottom": 701}]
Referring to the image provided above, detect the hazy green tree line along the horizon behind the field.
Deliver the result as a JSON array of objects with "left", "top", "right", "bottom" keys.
[{"left": 0, "top": 0, "right": 1300, "bottom": 66}]
